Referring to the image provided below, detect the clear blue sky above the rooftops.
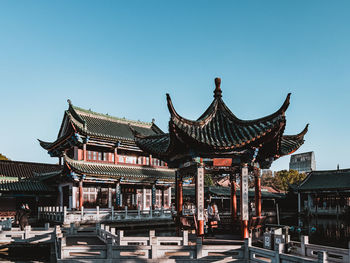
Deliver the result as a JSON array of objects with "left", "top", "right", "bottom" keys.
[{"left": 0, "top": 0, "right": 350, "bottom": 170}]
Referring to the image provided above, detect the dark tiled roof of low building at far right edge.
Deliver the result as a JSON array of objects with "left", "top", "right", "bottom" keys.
[{"left": 299, "top": 169, "right": 350, "bottom": 192}]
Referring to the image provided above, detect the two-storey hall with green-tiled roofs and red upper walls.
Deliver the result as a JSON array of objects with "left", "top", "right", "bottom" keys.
[{"left": 39, "top": 100, "right": 175, "bottom": 210}]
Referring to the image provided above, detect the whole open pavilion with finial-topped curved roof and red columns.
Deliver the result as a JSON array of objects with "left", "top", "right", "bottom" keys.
[{"left": 131, "top": 78, "right": 308, "bottom": 238}]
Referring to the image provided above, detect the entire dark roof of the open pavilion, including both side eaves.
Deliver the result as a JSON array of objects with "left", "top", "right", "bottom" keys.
[{"left": 131, "top": 78, "right": 308, "bottom": 169}]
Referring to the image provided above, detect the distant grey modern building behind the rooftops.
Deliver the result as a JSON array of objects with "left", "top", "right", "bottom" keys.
[{"left": 289, "top": 152, "right": 316, "bottom": 173}]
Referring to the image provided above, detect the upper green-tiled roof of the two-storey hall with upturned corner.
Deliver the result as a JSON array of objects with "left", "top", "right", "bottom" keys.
[{"left": 39, "top": 100, "right": 163, "bottom": 154}]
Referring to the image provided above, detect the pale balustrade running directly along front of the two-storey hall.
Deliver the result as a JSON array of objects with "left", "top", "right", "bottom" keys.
[{"left": 38, "top": 206, "right": 174, "bottom": 224}]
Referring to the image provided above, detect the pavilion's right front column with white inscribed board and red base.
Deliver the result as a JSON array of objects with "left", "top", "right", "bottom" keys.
[{"left": 240, "top": 164, "right": 249, "bottom": 239}]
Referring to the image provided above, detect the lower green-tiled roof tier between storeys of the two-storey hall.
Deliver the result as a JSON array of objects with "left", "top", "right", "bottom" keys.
[{"left": 64, "top": 155, "right": 175, "bottom": 182}]
